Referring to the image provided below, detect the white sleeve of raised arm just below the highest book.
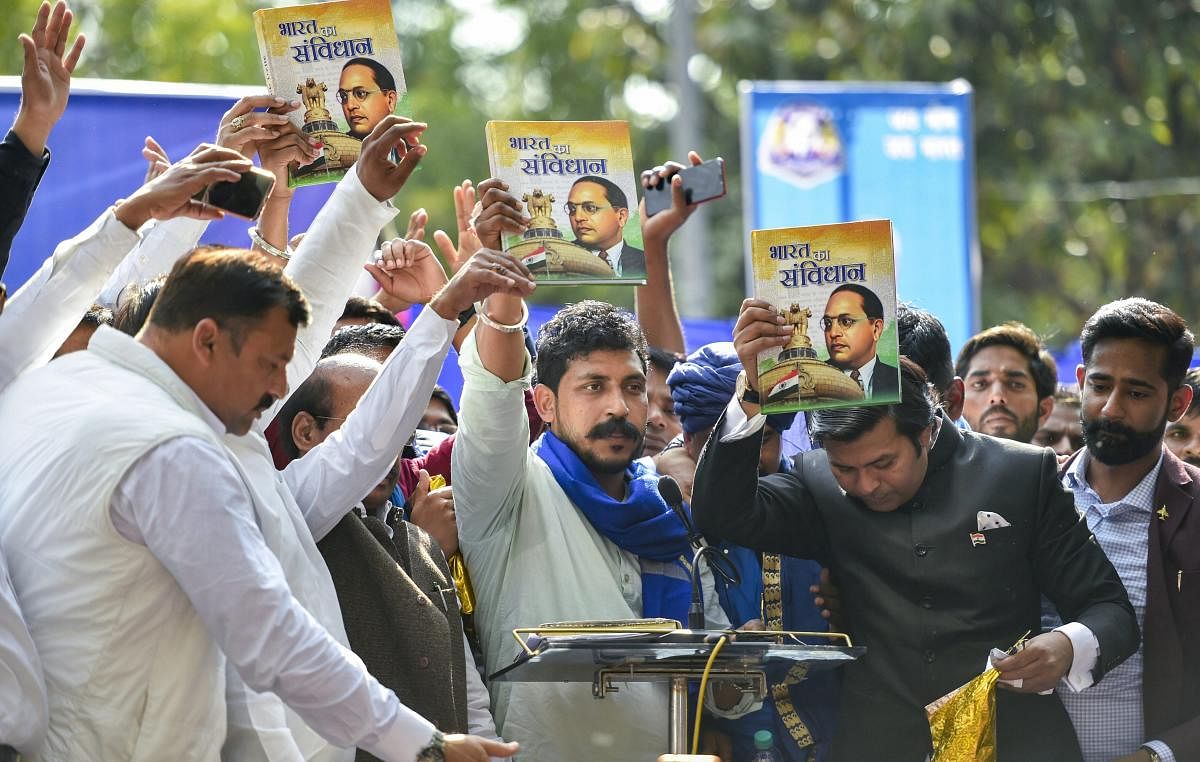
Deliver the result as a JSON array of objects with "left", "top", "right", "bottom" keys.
[{"left": 256, "top": 169, "right": 396, "bottom": 422}]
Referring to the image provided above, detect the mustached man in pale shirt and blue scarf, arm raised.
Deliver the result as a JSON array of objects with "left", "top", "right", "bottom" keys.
[{"left": 452, "top": 278, "right": 728, "bottom": 762}]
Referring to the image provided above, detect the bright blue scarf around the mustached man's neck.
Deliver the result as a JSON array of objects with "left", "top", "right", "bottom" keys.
[{"left": 533, "top": 431, "right": 691, "bottom": 624}]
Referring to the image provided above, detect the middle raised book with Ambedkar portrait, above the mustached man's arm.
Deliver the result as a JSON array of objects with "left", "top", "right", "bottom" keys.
[{"left": 484, "top": 121, "right": 646, "bottom": 284}]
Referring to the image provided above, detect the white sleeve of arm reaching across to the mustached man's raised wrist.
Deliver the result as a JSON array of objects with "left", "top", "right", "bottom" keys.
[{"left": 283, "top": 310, "right": 458, "bottom": 540}]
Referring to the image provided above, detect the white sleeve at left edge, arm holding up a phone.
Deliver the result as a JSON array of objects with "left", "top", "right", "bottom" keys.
[{"left": 0, "top": 208, "right": 138, "bottom": 389}]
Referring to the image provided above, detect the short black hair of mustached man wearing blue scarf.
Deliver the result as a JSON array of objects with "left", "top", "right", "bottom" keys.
[{"left": 538, "top": 299, "right": 647, "bottom": 394}]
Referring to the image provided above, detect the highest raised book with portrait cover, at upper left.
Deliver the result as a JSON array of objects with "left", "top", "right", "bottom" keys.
[{"left": 254, "top": 0, "right": 410, "bottom": 187}]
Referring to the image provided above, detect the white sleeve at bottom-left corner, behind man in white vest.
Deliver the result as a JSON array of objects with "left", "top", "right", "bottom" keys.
[{"left": 0, "top": 559, "right": 46, "bottom": 754}]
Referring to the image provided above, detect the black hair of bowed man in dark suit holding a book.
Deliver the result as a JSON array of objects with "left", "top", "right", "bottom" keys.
[{"left": 809, "top": 355, "right": 937, "bottom": 450}]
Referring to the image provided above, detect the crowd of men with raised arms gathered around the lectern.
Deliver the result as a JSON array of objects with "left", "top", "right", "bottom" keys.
[{"left": 0, "top": 0, "right": 1200, "bottom": 762}]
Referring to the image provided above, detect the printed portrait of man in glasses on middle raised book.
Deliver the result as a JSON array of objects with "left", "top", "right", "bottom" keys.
[{"left": 566, "top": 175, "right": 646, "bottom": 277}]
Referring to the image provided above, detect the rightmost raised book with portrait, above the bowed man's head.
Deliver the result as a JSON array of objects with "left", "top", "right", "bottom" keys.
[{"left": 750, "top": 220, "right": 900, "bottom": 414}]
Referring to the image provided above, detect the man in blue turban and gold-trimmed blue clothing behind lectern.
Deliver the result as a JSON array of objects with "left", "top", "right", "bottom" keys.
[{"left": 667, "top": 342, "right": 838, "bottom": 762}]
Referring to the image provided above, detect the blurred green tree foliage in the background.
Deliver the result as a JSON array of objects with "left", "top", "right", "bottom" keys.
[{"left": 0, "top": 0, "right": 1200, "bottom": 342}]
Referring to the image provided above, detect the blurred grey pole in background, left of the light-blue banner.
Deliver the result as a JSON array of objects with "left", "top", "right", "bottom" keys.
[{"left": 667, "top": 0, "right": 713, "bottom": 318}]
